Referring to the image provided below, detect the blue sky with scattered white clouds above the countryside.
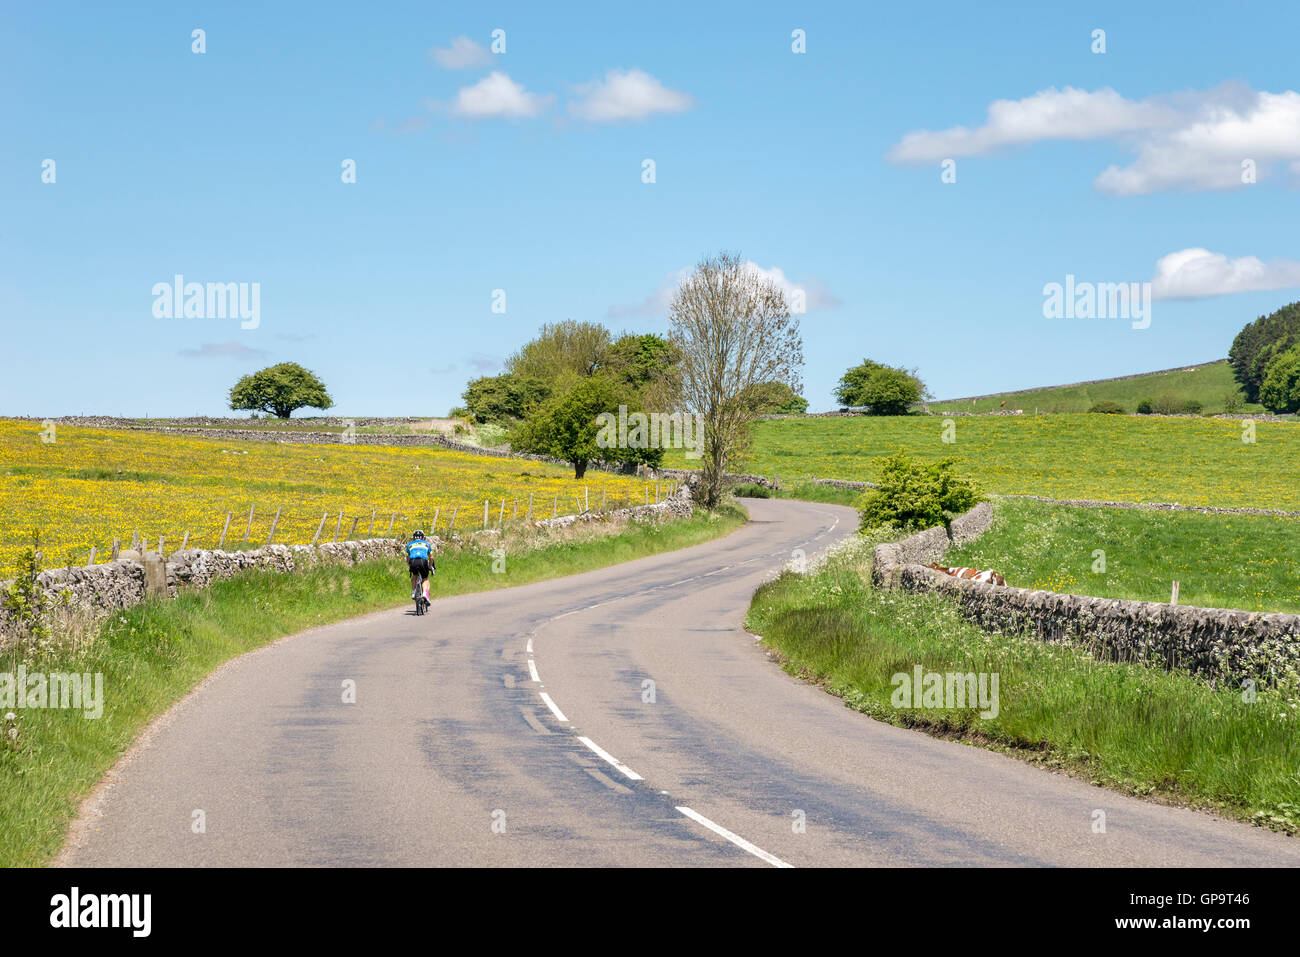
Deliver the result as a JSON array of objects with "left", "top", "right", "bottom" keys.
[{"left": 0, "top": 3, "right": 1300, "bottom": 416}]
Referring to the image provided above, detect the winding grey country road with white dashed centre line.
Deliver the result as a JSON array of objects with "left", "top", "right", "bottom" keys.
[{"left": 59, "top": 499, "right": 1300, "bottom": 867}]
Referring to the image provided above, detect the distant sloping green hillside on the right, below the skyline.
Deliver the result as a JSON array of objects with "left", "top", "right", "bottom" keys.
[{"left": 928, "top": 359, "right": 1261, "bottom": 413}]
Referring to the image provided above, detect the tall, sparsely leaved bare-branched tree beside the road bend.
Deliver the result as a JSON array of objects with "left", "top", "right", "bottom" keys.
[{"left": 668, "top": 252, "right": 803, "bottom": 508}]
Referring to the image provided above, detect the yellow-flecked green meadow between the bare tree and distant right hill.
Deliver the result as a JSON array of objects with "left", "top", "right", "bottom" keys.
[{"left": 664, "top": 415, "right": 1300, "bottom": 511}]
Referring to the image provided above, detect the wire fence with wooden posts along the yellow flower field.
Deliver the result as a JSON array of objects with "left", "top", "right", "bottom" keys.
[{"left": 65, "top": 481, "right": 679, "bottom": 566}]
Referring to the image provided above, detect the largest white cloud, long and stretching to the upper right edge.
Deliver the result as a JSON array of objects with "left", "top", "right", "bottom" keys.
[{"left": 889, "top": 83, "right": 1300, "bottom": 195}]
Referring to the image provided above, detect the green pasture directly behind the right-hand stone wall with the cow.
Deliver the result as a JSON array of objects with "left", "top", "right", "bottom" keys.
[{"left": 944, "top": 499, "right": 1300, "bottom": 612}]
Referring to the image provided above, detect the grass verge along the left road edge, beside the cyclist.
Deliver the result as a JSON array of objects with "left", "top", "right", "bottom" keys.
[{"left": 0, "top": 506, "right": 746, "bottom": 867}]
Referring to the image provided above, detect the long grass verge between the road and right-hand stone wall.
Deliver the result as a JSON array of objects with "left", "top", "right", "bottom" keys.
[{"left": 746, "top": 537, "right": 1300, "bottom": 833}]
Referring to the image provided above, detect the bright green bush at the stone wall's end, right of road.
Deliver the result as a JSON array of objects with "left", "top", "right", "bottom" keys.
[{"left": 858, "top": 451, "right": 984, "bottom": 529}]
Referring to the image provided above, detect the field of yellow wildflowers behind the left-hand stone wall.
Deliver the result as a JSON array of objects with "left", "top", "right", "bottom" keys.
[{"left": 0, "top": 420, "right": 655, "bottom": 577}]
